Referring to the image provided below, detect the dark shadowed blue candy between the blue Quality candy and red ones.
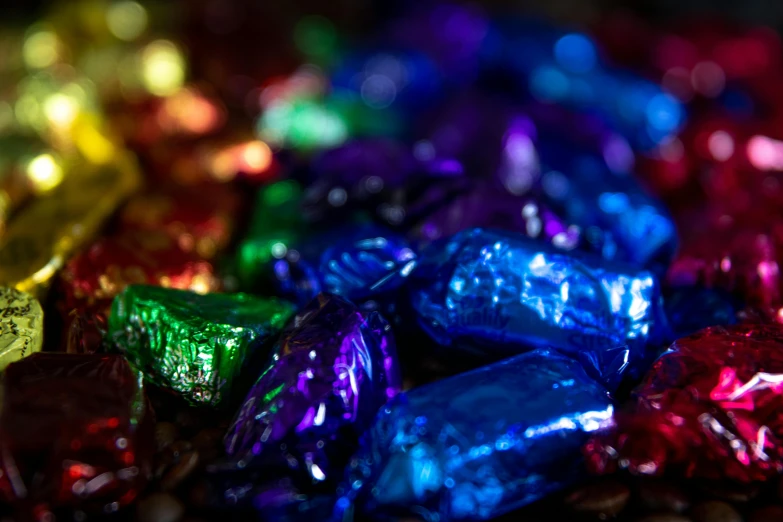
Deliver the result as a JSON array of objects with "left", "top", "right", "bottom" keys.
[{"left": 663, "top": 286, "right": 737, "bottom": 338}]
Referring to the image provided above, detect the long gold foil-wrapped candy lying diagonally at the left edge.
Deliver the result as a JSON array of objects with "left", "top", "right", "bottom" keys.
[{"left": 0, "top": 153, "right": 140, "bottom": 297}]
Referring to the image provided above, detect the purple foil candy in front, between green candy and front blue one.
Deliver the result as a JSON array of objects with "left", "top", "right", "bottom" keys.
[{"left": 226, "top": 294, "right": 401, "bottom": 500}]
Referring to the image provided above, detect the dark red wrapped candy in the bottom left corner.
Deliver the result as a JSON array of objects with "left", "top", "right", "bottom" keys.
[{"left": 0, "top": 353, "right": 154, "bottom": 520}]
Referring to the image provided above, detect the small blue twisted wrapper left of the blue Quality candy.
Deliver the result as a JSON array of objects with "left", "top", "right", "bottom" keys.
[{"left": 272, "top": 225, "right": 416, "bottom": 304}]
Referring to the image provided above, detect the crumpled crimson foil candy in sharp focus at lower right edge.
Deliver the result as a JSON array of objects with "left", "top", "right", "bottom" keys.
[{"left": 585, "top": 324, "right": 783, "bottom": 482}]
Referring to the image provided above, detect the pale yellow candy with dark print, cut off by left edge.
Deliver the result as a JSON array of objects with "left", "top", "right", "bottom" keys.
[{"left": 0, "top": 287, "right": 43, "bottom": 371}]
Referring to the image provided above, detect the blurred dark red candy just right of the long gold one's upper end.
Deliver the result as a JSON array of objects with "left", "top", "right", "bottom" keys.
[{"left": 120, "top": 184, "right": 240, "bottom": 259}]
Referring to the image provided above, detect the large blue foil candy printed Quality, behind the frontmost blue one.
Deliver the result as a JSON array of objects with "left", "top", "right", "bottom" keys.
[{"left": 410, "top": 229, "right": 666, "bottom": 387}]
